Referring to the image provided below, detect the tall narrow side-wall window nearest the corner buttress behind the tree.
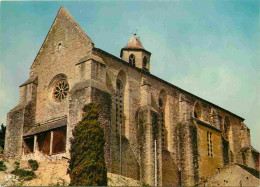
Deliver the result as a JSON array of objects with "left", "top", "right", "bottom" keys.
[{"left": 115, "top": 80, "right": 124, "bottom": 134}]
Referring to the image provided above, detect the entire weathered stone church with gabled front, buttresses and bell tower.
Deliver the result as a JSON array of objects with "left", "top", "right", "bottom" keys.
[{"left": 5, "top": 7, "right": 259, "bottom": 186}]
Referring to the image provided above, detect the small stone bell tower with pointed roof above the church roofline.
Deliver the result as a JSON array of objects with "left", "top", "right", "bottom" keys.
[{"left": 120, "top": 34, "right": 151, "bottom": 72}]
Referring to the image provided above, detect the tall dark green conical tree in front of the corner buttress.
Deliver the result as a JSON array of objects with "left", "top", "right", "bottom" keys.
[{"left": 68, "top": 103, "right": 107, "bottom": 186}]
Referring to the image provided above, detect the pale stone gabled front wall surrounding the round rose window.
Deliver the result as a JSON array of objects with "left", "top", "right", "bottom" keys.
[{"left": 30, "top": 8, "right": 93, "bottom": 123}]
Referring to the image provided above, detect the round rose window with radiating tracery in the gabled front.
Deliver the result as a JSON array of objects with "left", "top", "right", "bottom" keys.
[{"left": 53, "top": 80, "right": 69, "bottom": 102}]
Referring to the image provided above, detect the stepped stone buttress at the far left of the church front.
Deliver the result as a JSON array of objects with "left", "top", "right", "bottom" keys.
[{"left": 4, "top": 79, "right": 37, "bottom": 157}]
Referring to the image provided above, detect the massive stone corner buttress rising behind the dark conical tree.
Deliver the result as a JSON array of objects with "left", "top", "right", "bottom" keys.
[{"left": 67, "top": 54, "right": 111, "bottom": 171}]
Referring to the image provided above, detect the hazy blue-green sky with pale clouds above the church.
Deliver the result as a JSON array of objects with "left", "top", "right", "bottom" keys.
[{"left": 0, "top": 0, "right": 260, "bottom": 150}]
